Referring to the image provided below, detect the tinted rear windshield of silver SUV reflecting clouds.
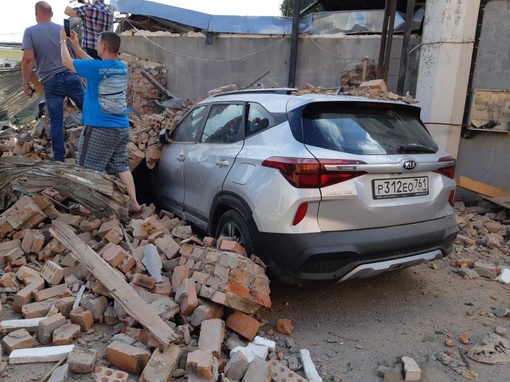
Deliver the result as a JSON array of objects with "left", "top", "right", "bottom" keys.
[{"left": 302, "top": 103, "right": 438, "bottom": 155}]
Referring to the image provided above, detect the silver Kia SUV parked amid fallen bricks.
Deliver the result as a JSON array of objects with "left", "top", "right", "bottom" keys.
[{"left": 155, "top": 88, "right": 458, "bottom": 283}]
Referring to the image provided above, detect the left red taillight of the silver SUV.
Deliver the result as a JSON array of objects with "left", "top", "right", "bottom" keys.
[{"left": 262, "top": 157, "right": 366, "bottom": 188}]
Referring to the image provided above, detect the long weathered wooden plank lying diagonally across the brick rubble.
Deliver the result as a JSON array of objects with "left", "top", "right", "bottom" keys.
[{"left": 50, "top": 220, "right": 178, "bottom": 346}]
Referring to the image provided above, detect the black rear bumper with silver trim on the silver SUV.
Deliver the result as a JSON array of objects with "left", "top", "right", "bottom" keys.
[{"left": 256, "top": 215, "right": 459, "bottom": 282}]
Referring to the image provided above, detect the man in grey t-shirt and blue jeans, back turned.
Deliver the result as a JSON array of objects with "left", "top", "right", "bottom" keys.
[{"left": 21, "top": 1, "right": 84, "bottom": 162}]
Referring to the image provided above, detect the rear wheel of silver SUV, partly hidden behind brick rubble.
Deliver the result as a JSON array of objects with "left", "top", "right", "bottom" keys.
[{"left": 216, "top": 210, "right": 256, "bottom": 256}]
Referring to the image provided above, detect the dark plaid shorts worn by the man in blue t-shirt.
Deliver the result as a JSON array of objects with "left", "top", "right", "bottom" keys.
[{"left": 78, "top": 125, "right": 129, "bottom": 174}]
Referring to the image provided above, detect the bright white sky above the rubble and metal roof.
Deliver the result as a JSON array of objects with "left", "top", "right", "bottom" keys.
[{"left": 0, "top": 0, "right": 282, "bottom": 42}]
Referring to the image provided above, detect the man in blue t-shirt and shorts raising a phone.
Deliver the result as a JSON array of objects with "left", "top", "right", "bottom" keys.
[{"left": 60, "top": 28, "right": 143, "bottom": 217}]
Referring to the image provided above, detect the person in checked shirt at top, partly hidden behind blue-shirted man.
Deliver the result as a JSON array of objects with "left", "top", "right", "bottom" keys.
[{"left": 64, "top": 0, "right": 113, "bottom": 60}]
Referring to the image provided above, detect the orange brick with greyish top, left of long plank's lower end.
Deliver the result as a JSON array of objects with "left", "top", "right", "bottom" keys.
[{"left": 106, "top": 341, "right": 151, "bottom": 374}]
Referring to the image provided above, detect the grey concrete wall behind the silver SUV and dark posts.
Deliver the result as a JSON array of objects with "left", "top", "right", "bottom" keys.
[{"left": 122, "top": 31, "right": 420, "bottom": 99}]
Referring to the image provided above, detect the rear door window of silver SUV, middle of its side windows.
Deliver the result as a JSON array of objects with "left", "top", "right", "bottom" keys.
[{"left": 201, "top": 104, "right": 243, "bottom": 143}]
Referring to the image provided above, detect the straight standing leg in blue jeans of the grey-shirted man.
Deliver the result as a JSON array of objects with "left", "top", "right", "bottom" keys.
[{"left": 43, "top": 77, "right": 66, "bottom": 162}]
